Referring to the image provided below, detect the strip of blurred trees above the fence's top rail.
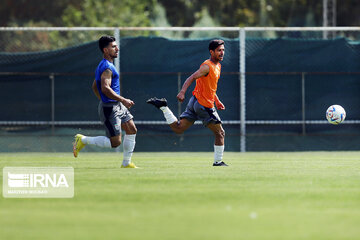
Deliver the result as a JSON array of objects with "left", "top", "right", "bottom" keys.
[{"left": 0, "top": 0, "right": 360, "bottom": 27}]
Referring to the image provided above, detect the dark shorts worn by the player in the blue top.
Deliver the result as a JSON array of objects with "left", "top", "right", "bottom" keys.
[{"left": 98, "top": 101, "right": 134, "bottom": 138}]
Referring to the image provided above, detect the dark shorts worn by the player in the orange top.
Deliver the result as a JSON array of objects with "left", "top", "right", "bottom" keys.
[{"left": 180, "top": 96, "right": 221, "bottom": 126}]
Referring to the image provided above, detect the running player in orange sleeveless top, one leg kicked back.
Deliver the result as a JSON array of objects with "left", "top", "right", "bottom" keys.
[{"left": 147, "top": 40, "right": 227, "bottom": 166}]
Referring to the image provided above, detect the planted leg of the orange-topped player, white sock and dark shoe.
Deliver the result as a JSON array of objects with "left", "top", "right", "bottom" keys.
[{"left": 207, "top": 123, "right": 228, "bottom": 166}]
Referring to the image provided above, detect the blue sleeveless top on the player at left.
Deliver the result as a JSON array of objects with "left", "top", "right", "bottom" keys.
[{"left": 95, "top": 58, "right": 120, "bottom": 103}]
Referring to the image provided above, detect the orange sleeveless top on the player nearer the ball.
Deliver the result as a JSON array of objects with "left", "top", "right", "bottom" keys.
[{"left": 192, "top": 59, "right": 221, "bottom": 108}]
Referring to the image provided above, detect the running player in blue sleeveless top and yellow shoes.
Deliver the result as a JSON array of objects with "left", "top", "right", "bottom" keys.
[{"left": 73, "top": 36, "right": 137, "bottom": 168}]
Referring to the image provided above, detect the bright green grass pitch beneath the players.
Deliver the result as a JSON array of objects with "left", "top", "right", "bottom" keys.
[{"left": 0, "top": 152, "right": 360, "bottom": 240}]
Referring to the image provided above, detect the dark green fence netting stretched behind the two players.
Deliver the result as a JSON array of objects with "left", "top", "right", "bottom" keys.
[{"left": 0, "top": 37, "right": 360, "bottom": 151}]
